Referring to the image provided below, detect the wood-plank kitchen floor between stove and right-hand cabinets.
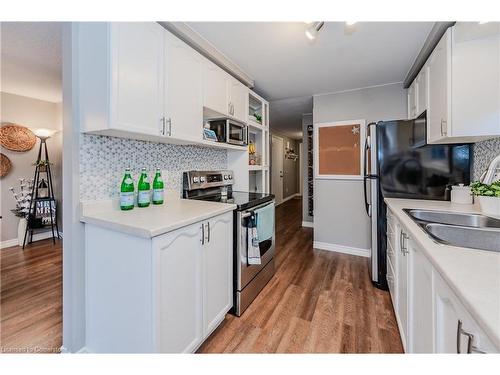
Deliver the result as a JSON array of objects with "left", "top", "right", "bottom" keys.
[{"left": 198, "top": 199, "right": 403, "bottom": 353}]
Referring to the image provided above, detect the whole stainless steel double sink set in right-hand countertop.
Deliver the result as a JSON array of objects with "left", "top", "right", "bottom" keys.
[{"left": 404, "top": 209, "right": 500, "bottom": 252}]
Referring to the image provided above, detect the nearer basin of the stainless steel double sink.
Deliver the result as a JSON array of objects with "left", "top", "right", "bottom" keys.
[{"left": 424, "top": 223, "right": 500, "bottom": 252}]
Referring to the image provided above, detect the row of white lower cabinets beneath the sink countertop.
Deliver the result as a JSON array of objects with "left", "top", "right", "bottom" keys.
[{"left": 387, "top": 210, "right": 500, "bottom": 353}]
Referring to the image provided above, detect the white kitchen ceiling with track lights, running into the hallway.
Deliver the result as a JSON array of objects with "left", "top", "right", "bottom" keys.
[{"left": 188, "top": 22, "right": 433, "bottom": 140}]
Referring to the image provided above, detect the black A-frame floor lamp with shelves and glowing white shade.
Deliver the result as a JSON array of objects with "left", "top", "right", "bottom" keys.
[{"left": 23, "top": 129, "right": 59, "bottom": 249}]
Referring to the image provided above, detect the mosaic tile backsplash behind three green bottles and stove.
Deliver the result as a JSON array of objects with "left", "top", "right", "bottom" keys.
[{"left": 80, "top": 134, "right": 227, "bottom": 200}]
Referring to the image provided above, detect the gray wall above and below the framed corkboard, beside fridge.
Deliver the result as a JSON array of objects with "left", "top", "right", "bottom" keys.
[{"left": 313, "top": 84, "right": 407, "bottom": 249}]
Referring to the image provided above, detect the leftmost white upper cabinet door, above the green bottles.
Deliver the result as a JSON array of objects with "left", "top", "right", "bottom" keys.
[{"left": 111, "top": 22, "right": 165, "bottom": 135}]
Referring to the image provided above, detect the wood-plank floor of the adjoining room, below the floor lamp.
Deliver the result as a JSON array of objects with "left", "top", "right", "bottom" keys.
[{"left": 0, "top": 239, "right": 62, "bottom": 353}]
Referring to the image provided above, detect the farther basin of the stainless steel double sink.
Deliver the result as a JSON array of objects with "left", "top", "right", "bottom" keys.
[{"left": 405, "top": 210, "right": 500, "bottom": 228}]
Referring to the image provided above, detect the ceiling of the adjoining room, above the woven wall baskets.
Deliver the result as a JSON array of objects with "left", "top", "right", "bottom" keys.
[{"left": 0, "top": 22, "right": 62, "bottom": 103}]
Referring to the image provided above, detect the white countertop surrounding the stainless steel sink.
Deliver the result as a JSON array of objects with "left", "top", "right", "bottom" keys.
[{"left": 385, "top": 198, "right": 500, "bottom": 348}]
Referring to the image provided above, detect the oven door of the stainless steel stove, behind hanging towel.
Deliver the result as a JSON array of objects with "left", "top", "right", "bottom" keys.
[{"left": 236, "top": 201, "right": 275, "bottom": 291}]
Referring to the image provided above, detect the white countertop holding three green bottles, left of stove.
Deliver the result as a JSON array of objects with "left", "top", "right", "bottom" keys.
[{"left": 80, "top": 198, "right": 236, "bottom": 238}]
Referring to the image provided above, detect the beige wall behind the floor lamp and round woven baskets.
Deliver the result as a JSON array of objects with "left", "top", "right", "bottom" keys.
[{"left": 0, "top": 92, "right": 62, "bottom": 241}]
